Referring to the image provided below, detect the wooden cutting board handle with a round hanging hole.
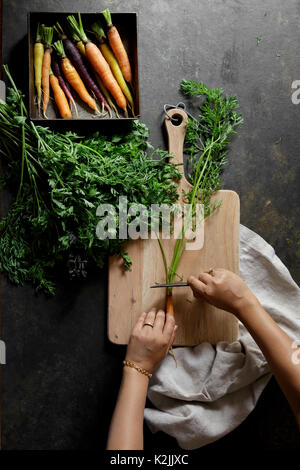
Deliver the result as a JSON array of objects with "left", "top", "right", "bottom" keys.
[{"left": 165, "top": 108, "right": 192, "bottom": 203}]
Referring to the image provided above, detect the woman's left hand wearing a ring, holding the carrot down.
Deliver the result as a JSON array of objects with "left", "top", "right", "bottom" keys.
[{"left": 125, "top": 308, "right": 177, "bottom": 372}]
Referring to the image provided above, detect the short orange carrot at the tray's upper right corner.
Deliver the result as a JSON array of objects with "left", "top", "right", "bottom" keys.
[{"left": 102, "top": 8, "right": 132, "bottom": 83}]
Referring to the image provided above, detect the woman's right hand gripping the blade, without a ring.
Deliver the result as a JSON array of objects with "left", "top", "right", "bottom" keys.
[{"left": 188, "top": 268, "right": 259, "bottom": 317}]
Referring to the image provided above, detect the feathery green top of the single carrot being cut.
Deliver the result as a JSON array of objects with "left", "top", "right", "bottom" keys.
[{"left": 160, "top": 80, "right": 243, "bottom": 295}]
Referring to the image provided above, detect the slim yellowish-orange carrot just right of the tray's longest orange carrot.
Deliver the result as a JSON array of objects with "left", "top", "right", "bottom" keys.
[{"left": 92, "top": 23, "right": 134, "bottom": 115}]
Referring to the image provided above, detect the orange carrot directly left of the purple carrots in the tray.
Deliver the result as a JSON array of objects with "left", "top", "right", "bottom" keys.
[{"left": 53, "top": 41, "right": 99, "bottom": 112}]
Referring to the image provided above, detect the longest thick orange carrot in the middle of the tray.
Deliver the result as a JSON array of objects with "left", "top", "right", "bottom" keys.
[{"left": 67, "top": 13, "right": 127, "bottom": 112}]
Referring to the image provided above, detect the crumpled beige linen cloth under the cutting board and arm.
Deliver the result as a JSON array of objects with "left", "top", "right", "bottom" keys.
[{"left": 145, "top": 225, "right": 300, "bottom": 449}]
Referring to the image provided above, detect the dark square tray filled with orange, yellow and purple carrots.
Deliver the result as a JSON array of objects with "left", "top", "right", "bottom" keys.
[{"left": 28, "top": 9, "right": 140, "bottom": 121}]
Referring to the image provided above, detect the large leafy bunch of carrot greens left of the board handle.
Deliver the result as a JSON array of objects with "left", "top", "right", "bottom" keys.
[{"left": 0, "top": 68, "right": 180, "bottom": 294}]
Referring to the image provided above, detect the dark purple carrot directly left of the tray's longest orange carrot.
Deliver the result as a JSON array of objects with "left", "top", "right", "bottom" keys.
[{"left": 55, "top": 23, "right": 111, "bottom": 112}]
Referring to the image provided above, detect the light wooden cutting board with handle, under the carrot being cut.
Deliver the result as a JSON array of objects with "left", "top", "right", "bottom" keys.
[{"left": 108, "top": 109, "right": 240, "bottom": 346}]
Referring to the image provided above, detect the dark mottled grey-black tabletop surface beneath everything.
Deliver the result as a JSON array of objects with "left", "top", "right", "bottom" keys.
[{"left": 1, "top": 0, "right": 300, "bottom": 455}]
